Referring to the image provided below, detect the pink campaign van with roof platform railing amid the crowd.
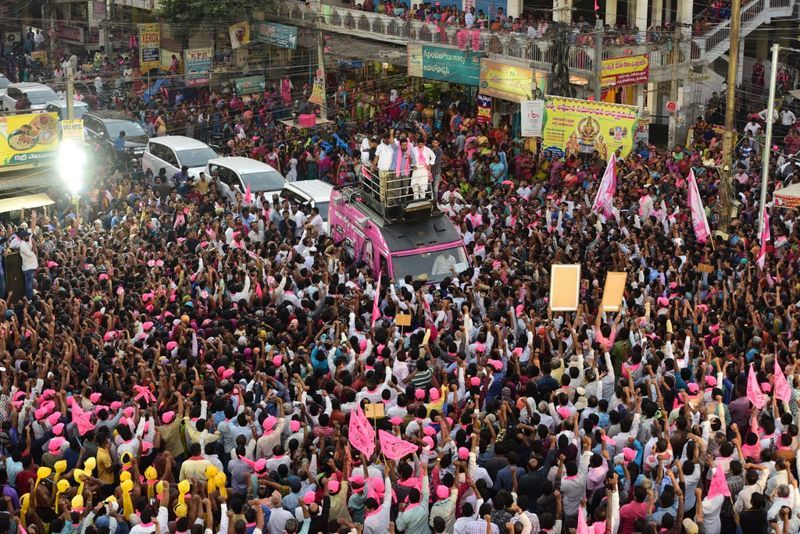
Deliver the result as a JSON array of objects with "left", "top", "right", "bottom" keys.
[{"left": 328, "top": 170, "right": 468, "bottom": 283}]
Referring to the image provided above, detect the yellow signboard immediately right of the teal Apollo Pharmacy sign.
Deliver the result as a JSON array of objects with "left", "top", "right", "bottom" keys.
[{"left": 479, "top": 58, "right": 547, "bottom": 103}]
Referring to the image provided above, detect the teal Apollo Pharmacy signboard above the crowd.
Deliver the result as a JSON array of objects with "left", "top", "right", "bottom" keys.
[{"left": 408, "top": 44, "right": 481, "bottom": 86}]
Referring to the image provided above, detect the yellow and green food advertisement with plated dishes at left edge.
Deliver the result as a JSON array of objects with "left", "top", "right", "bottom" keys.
[{"left": 0, "top": 113, "right": 58, "bottom": 167}]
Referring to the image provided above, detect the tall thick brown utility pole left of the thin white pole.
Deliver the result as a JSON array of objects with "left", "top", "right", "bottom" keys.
[{"left": 719, "top": 0, "right": 744, "bottom": 232}]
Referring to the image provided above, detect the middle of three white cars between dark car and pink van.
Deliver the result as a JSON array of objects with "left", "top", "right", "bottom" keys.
[{"left": 206, "top": 156, "right": 286, "bottom": 203}]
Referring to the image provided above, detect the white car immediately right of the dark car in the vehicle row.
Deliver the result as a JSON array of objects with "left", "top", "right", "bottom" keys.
[{"left": 142, "top": 135, "right": 218, "bottom": 178}]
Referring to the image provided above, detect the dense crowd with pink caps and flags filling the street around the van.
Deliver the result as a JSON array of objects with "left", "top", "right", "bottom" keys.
[{"left": 0, "top": 44, "right": 800, "bottom": 534}]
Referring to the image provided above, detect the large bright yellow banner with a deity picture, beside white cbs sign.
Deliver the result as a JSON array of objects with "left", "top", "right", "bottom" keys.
[{"left": 542, "top": 96, "right": 639, "bottom": 160}]
